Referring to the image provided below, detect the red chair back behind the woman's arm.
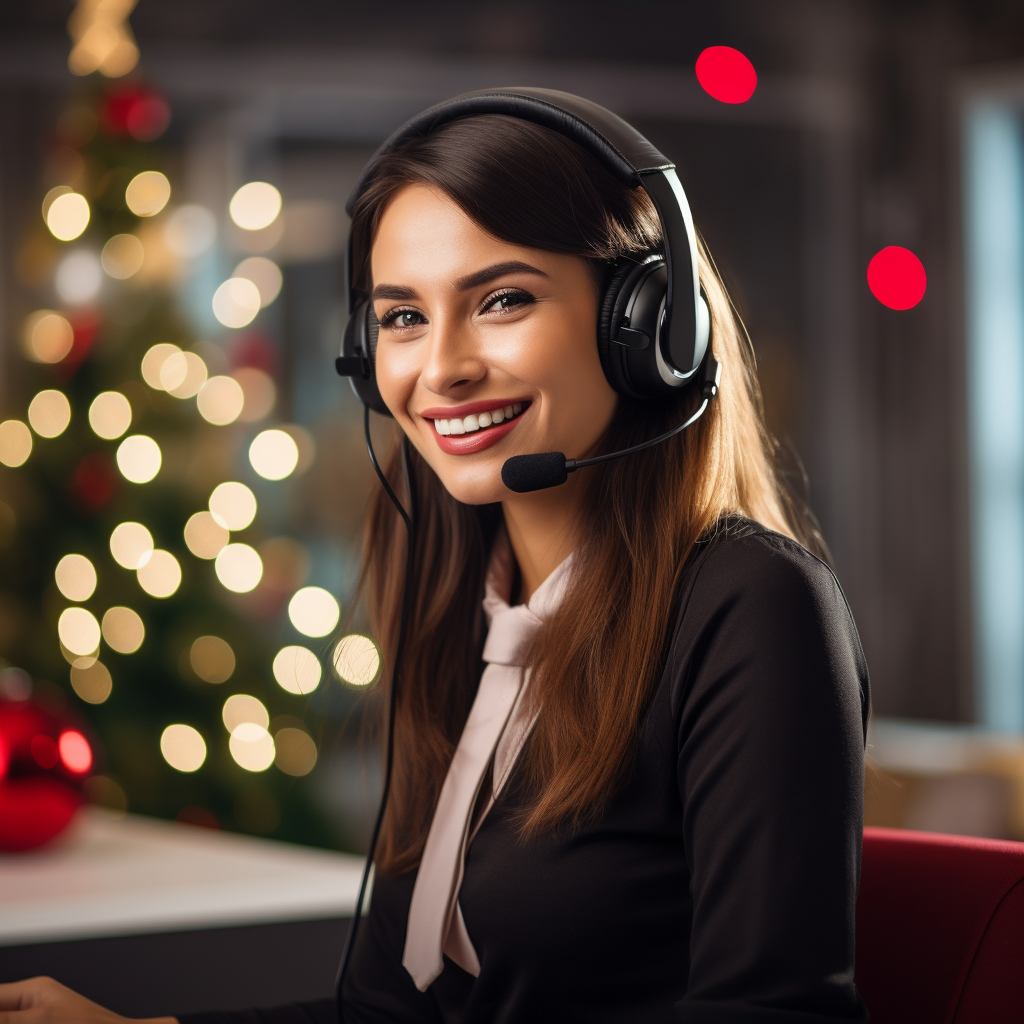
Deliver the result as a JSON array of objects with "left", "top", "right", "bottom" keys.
[{"left": 856, "top": 828, "right": 1024, "bottom": 1024}]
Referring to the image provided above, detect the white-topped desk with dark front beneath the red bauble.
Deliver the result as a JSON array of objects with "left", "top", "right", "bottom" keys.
[{"left": 0, "top": 810, "right": 364, "bottom": 1016}]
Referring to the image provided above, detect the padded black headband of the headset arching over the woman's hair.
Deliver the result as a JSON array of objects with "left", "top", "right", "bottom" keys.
[{"left": 345, "top": 88, "right": 705, "bottom": 379}]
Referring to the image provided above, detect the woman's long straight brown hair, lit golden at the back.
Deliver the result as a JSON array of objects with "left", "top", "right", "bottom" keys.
[{"left": 352, "top": 115, "right": 816, "bottom": 874}]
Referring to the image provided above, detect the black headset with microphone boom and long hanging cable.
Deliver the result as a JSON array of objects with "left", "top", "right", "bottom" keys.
[{"left": 335, "top": 88, "right": 721, "bottom": 999}]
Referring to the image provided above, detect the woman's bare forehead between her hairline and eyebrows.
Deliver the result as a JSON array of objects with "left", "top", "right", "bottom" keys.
[{"left": 370, "top": 184, "right": 536, "bottom": 285}]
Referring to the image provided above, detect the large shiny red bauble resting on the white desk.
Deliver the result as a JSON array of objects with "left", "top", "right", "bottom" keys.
[{"left": 0, "top": 698, "right": 93, "bottom": 853}]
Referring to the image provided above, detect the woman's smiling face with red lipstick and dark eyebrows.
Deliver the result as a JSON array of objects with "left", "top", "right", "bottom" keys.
[{"left": 371, "top": 184, "right": 616, "bottom": 505}]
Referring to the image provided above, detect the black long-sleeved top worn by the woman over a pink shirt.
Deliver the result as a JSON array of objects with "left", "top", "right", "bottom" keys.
[{"left": 180, "top": 519, "right": 868, "bottom": 1024}]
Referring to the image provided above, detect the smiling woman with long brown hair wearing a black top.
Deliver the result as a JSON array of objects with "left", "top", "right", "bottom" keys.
[{"left": 0, "top": 97, "right": 867, "bottom": 1024}]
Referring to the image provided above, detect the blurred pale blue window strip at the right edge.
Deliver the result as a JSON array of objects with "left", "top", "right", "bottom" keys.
[{"left": 964, "top": 99, "right": 1024, "bottom": 731}]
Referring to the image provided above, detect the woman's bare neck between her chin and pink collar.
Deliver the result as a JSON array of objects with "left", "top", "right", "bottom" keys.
[{"left": 502, "top": 476, "right": 580, "bottom": 604}]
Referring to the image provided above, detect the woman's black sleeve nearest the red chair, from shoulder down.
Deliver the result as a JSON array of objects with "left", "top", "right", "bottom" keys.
[{"left": 671, "top": 532, "right": 868, "bottom": 1024}]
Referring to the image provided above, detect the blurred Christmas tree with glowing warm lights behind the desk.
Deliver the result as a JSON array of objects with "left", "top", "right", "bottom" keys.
[{"left": 0, "top": 59, "right": 379, "bottom": 847}]
